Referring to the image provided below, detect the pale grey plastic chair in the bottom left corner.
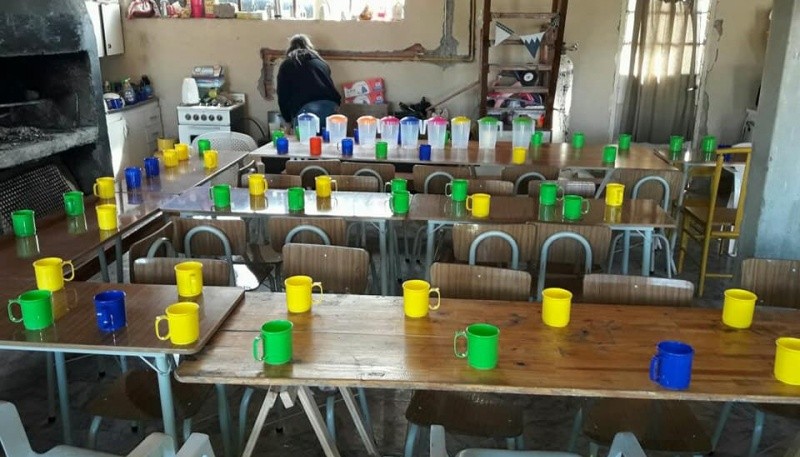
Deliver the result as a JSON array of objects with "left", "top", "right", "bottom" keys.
[{"left": 0, "top": 401, "right": 176, "bottom": 457}]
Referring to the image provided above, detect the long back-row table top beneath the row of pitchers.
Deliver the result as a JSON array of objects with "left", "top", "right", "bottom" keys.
[{"left": 253, "top": 140, "right": 674, "bottom": 170}]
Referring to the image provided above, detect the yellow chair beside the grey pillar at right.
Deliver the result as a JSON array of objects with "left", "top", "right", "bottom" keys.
[{"left": 678, "top": 148, "right": 752, "bottom": 297}]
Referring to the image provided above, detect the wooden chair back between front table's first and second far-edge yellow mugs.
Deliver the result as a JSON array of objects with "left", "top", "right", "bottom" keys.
[{"left": 283, "top": 243, "right": 369, "bottom": 294}]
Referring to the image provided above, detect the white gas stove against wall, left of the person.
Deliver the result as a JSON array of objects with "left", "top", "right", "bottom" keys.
[{"left": 178, "top": 103, "right": 245, "bottom": 144}]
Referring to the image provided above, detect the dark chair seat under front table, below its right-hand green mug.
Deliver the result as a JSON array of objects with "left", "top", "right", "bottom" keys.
[{"left": 406, "top": 390, "right": 524, "bottom": 438}]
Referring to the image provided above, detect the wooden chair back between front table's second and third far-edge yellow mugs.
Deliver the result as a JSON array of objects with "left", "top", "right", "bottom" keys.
[{"left": 431, "top": 262, "right": 531, "bottom": 301}]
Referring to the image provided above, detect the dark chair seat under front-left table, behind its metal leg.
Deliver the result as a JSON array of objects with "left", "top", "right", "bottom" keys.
[{"left": 86, "top": 370, "right": 211, "bottom": 421}]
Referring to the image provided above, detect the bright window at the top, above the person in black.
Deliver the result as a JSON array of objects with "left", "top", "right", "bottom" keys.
[{"left": 238, "top": 0, "right": 406, "bottom": 22}]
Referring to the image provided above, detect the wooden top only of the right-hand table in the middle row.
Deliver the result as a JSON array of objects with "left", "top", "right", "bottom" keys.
[{"left": 408, "top": 194, "right": 675, "bottom": 229}]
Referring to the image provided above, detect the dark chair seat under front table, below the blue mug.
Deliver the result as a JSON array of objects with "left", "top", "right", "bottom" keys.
[{"left": 583, "top": 398, "right": 713, "bottom": 454}]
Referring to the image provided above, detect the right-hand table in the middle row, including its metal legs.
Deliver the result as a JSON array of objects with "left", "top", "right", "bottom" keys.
[{"left": 408, "top": 194, "right": 675, "bottom": 277}]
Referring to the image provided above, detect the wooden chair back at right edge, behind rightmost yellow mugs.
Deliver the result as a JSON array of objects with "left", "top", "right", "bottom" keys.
[{"left": 741, "top": 259, "right": 800, "bottom": 308}]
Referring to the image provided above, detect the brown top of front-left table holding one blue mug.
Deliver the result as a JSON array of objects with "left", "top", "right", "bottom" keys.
[{"left": 0, "top": 278, "right": 244, "bottom": 354}]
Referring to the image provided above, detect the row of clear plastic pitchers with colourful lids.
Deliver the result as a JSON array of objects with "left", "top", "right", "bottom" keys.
[{"left": 297, "top": 113, "right": 534, "bottom": 149}]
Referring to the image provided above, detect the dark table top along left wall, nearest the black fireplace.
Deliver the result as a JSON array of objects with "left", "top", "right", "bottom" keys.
[{"left": 0, "top": 193, "right": 165, "bottom": 278}]
